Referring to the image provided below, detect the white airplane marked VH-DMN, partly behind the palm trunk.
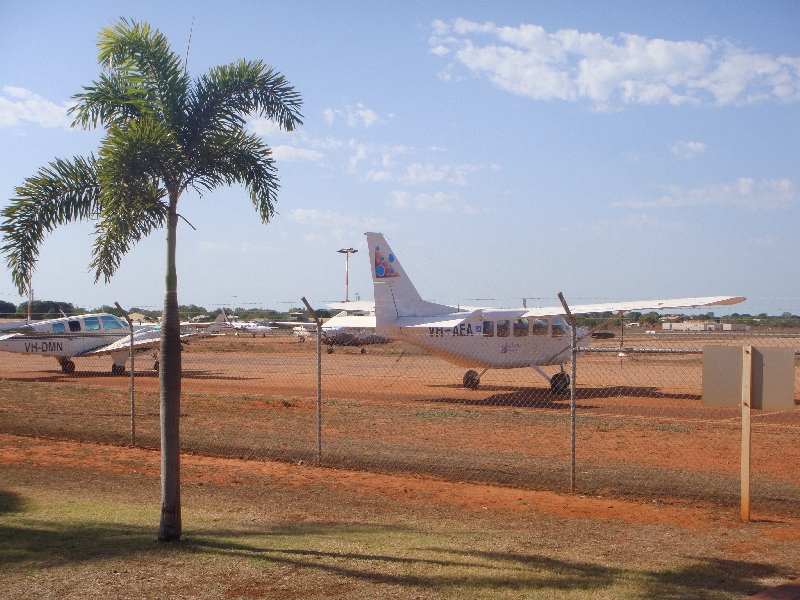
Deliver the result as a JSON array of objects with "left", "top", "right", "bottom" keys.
[{"left": 0, "top": 313, "right": 213, "bottom": 375}]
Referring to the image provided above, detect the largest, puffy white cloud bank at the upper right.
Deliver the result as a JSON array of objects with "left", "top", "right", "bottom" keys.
[{"left": 429, "top": 19, "right": 800, "bottom": 110}]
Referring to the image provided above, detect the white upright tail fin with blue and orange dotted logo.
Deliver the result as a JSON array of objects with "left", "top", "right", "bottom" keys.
[{"left": 366, "top": 233, "right": 457, "bottom": 331}]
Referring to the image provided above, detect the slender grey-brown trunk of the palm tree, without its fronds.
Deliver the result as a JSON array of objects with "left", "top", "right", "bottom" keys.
[{"left": 158, "top": 193, "right": 181, "bottom": 542}]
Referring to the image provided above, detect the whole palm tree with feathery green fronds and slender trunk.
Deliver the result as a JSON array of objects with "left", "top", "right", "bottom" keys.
[{"left": 0, "top": 19, "right": 302, "bottom": 541}]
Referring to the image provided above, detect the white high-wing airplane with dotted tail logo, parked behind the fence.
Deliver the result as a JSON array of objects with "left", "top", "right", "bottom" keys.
[{"left": 366, "top": 233, "right": 745, "bottom": 393}]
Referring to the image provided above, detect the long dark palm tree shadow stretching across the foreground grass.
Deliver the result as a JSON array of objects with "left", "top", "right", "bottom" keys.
[{"left": 0, "top": 512, "right": 782, "bottom": 600}]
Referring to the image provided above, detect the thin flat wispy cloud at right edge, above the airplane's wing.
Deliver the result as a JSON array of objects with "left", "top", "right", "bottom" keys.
[{"left": 611, "top": 177, "right": 797, "bottom": 210}]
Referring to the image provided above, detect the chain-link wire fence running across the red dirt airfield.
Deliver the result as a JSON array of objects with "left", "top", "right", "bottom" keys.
[{"left": 0, "top": 325, "right": 800, "bottom": 514}]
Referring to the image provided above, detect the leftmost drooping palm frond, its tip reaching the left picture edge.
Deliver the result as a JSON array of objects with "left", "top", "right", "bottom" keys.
[{"left": 0, "top": 156, "right": 100, "bottom": 294}]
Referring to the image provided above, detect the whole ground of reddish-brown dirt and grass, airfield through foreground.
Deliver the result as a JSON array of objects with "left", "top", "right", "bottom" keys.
[{"left": 0, "top": 336, "right": 800, "bottom": 598}]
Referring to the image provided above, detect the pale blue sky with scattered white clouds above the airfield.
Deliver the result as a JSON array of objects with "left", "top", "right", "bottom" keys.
[{"left": 0, "top": 0, "right": 800, "bottom": 315}]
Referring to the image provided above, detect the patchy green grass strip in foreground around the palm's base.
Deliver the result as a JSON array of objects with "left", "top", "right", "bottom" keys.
[{"left": 0, "top": 482, "right": 779, "bottom": 599}]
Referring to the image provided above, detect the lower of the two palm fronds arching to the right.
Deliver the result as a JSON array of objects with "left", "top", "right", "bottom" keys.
[{"left": 192, "top": 130, "right": 280, "bottom": 223}]
